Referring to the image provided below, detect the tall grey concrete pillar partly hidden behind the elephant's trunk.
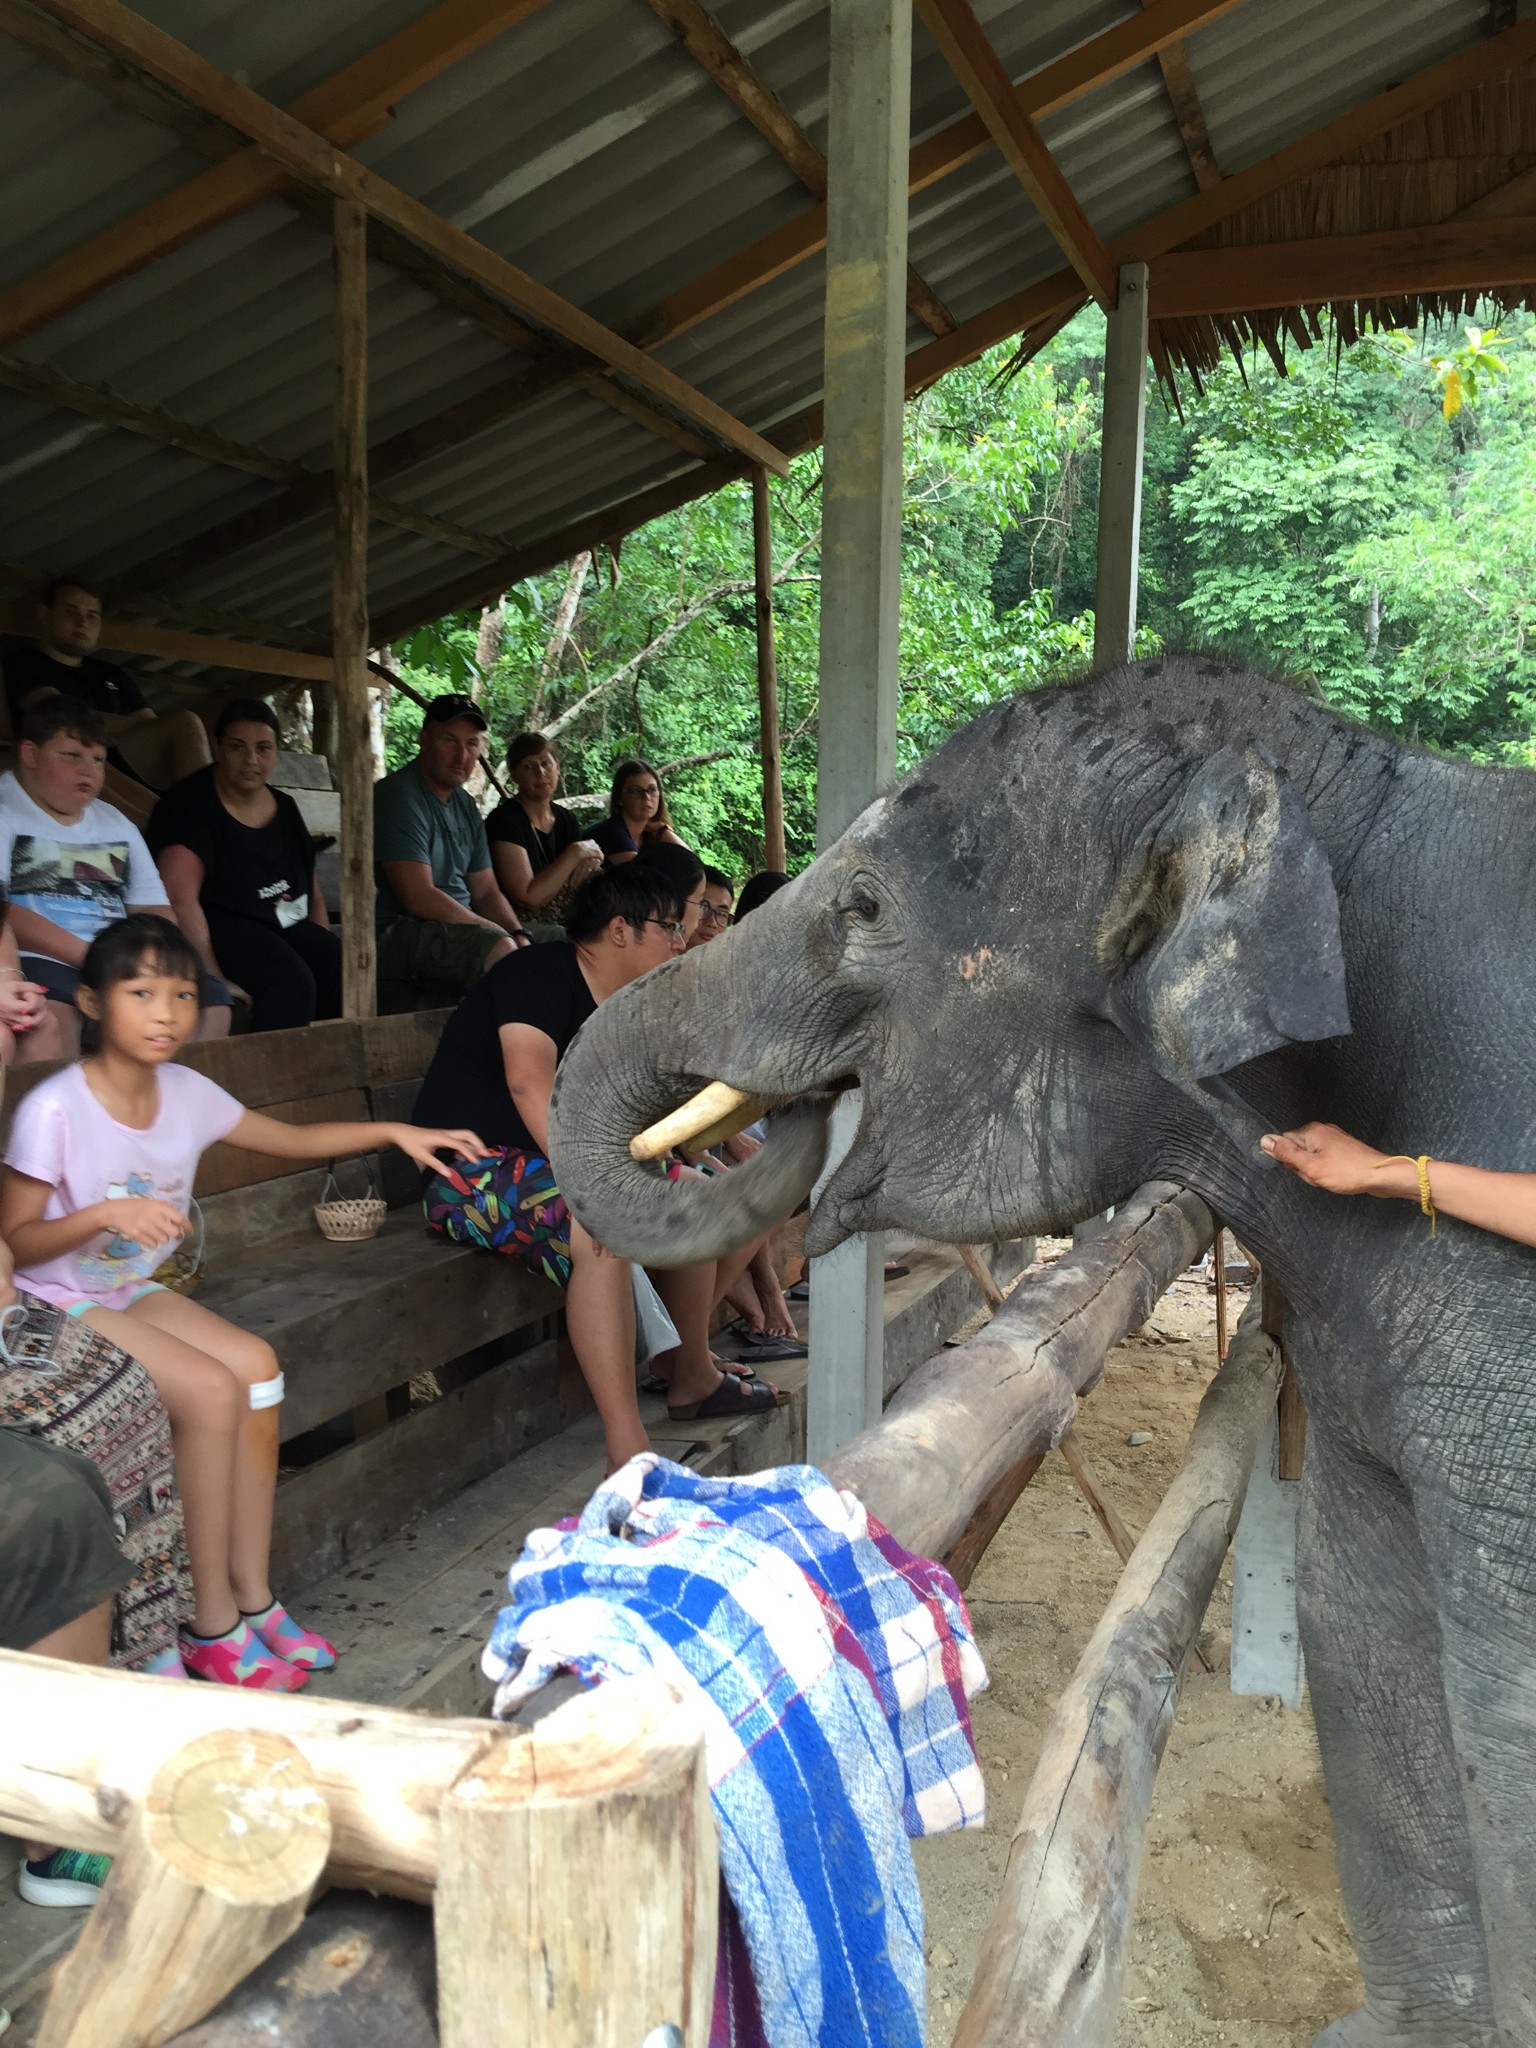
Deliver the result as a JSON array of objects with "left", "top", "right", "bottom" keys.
[{"left": 807, "top": 0, "right": 911, "bottom": 1462}]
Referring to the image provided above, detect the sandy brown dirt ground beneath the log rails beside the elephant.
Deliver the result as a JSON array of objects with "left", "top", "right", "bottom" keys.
[{"left": 915, "top": 1245, "right": 1360, "bottom": 2048}]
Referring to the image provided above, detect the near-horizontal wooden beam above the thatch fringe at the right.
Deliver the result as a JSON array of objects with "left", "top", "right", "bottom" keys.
[{"left": 1149, "top": 219, "right": 1536, "bottom": 319}]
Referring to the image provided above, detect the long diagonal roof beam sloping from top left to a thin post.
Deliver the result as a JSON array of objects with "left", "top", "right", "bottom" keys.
[{"left": 20, "top": 0, "right": 784, "bottom": 471}]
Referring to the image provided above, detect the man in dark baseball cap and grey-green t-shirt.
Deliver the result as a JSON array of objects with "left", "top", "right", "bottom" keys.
[{"left": 373, "top": 696, "right": 528, "bottom": 1001}]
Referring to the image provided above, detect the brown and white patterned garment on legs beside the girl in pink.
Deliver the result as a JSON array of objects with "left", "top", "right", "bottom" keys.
[{"left": 0, "top": 1292, "right": 193, "bottom": 1669}]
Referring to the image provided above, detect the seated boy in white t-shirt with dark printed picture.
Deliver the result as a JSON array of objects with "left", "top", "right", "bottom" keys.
[{"left": 0, "top": 696, "right": 229, "bottom": 1057}]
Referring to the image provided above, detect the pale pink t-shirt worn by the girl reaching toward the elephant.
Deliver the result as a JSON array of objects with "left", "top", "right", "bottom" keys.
[{"left": 6, "top": 1065, "right": 246, "bottom": 1309}]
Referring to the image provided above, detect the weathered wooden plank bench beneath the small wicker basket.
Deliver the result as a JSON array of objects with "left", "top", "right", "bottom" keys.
[{"left": 8, "top": 1012, "right": 573, "bottom": 1591}]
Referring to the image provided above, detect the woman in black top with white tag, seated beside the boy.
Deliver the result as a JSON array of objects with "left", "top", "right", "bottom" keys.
[{"left": 145, "top": 696, "right": 342, "bottom": 1030}]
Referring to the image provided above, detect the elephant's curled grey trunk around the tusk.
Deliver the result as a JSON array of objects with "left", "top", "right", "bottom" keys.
[{"left": 549, "top": 940, "right": 827, "bottom": 1266}]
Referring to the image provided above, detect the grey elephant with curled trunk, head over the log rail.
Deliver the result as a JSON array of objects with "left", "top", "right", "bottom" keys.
[{"left": 551, "top": 659, "right": 1536, "bottom": 2044}]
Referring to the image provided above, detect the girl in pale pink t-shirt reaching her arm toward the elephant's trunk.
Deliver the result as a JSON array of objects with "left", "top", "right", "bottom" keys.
[{"left": 0, "top": 915, "right": 485, "bottom": 1692}]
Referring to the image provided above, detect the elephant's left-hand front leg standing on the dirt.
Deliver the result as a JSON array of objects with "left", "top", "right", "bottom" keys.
[{"left": 1296, "top": 1427, "right": 1493, "bottom": 2048}]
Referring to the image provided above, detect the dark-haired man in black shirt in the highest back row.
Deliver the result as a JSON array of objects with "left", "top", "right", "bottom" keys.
[{"left": 4, "top": 575, "right": 209, "bottom": 788}]
